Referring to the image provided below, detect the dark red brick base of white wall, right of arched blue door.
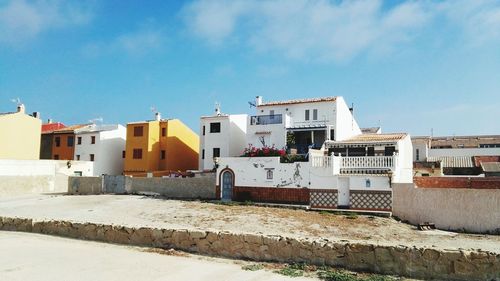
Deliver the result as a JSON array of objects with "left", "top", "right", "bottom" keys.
[{"left": 233, "top": 186, "right": 309, "bottom": 205}]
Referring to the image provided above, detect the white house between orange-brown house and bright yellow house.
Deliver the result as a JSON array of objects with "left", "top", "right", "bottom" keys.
[{"left": 74, "top": 124, "right": 127, "bottom": 175}]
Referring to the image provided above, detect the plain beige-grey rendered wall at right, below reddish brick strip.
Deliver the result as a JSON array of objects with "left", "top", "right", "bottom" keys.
[{"left": 392, "top": 184, "right": 500, "bottom": 234}]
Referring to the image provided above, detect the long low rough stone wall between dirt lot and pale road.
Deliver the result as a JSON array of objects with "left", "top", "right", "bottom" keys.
[{"left": 0, "top": 217, "right": 500, "bottom": 280}]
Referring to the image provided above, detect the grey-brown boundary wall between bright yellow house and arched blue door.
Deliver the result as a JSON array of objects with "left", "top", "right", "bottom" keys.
[{"left": 127, "top": 175, "right": 217, "bottom": 199}]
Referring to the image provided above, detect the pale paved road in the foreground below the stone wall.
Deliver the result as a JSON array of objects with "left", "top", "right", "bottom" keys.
[{"left": 0, "top": 231, "right": 313, "bottom": 281}]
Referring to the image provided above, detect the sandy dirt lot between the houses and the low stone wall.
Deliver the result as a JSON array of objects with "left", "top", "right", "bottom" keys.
[{"left": 0, "top": 195, "right": 500, "bottom": 254}]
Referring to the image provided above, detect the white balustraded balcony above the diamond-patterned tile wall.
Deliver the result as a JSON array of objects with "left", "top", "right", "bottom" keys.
[{"left": 309, "top": 154, "right": 398, "bottom": 175}]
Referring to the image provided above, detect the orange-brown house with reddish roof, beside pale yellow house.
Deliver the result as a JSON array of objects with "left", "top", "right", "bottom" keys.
[{"left": 40, "top": 124, "right": 92, "bottom": 160}]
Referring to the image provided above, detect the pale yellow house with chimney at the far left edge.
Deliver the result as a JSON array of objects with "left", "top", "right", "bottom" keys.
[{"left": 0, "top": 104, "right": 42, "bottom": 160}]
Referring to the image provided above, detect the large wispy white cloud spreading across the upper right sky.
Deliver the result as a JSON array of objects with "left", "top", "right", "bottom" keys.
[{"left": 181, "top": 0, "right": 500, "bottom": 62}]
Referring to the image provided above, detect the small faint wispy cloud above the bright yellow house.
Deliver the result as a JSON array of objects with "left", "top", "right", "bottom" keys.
[{"left": 82, "top": 24, "right": 166, "bottom": 57}]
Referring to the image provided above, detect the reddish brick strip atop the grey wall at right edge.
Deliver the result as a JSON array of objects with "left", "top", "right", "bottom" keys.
[{"left": 413, "top": 177, "right": 500, "bottom": 189}]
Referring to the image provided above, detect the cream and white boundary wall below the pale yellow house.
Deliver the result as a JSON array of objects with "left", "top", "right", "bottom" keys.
[{"left": 0, "top": 160, "right": 93, "bottom": 196}]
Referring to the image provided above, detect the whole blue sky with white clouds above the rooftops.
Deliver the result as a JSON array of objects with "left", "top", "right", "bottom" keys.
[{"left": 0, "top": 0, "right": 500, "bottom": 135}]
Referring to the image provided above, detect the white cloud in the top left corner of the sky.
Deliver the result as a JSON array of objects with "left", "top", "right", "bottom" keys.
[{"left": 0, "top": 0, "right": 92, "bottom": 45}]
